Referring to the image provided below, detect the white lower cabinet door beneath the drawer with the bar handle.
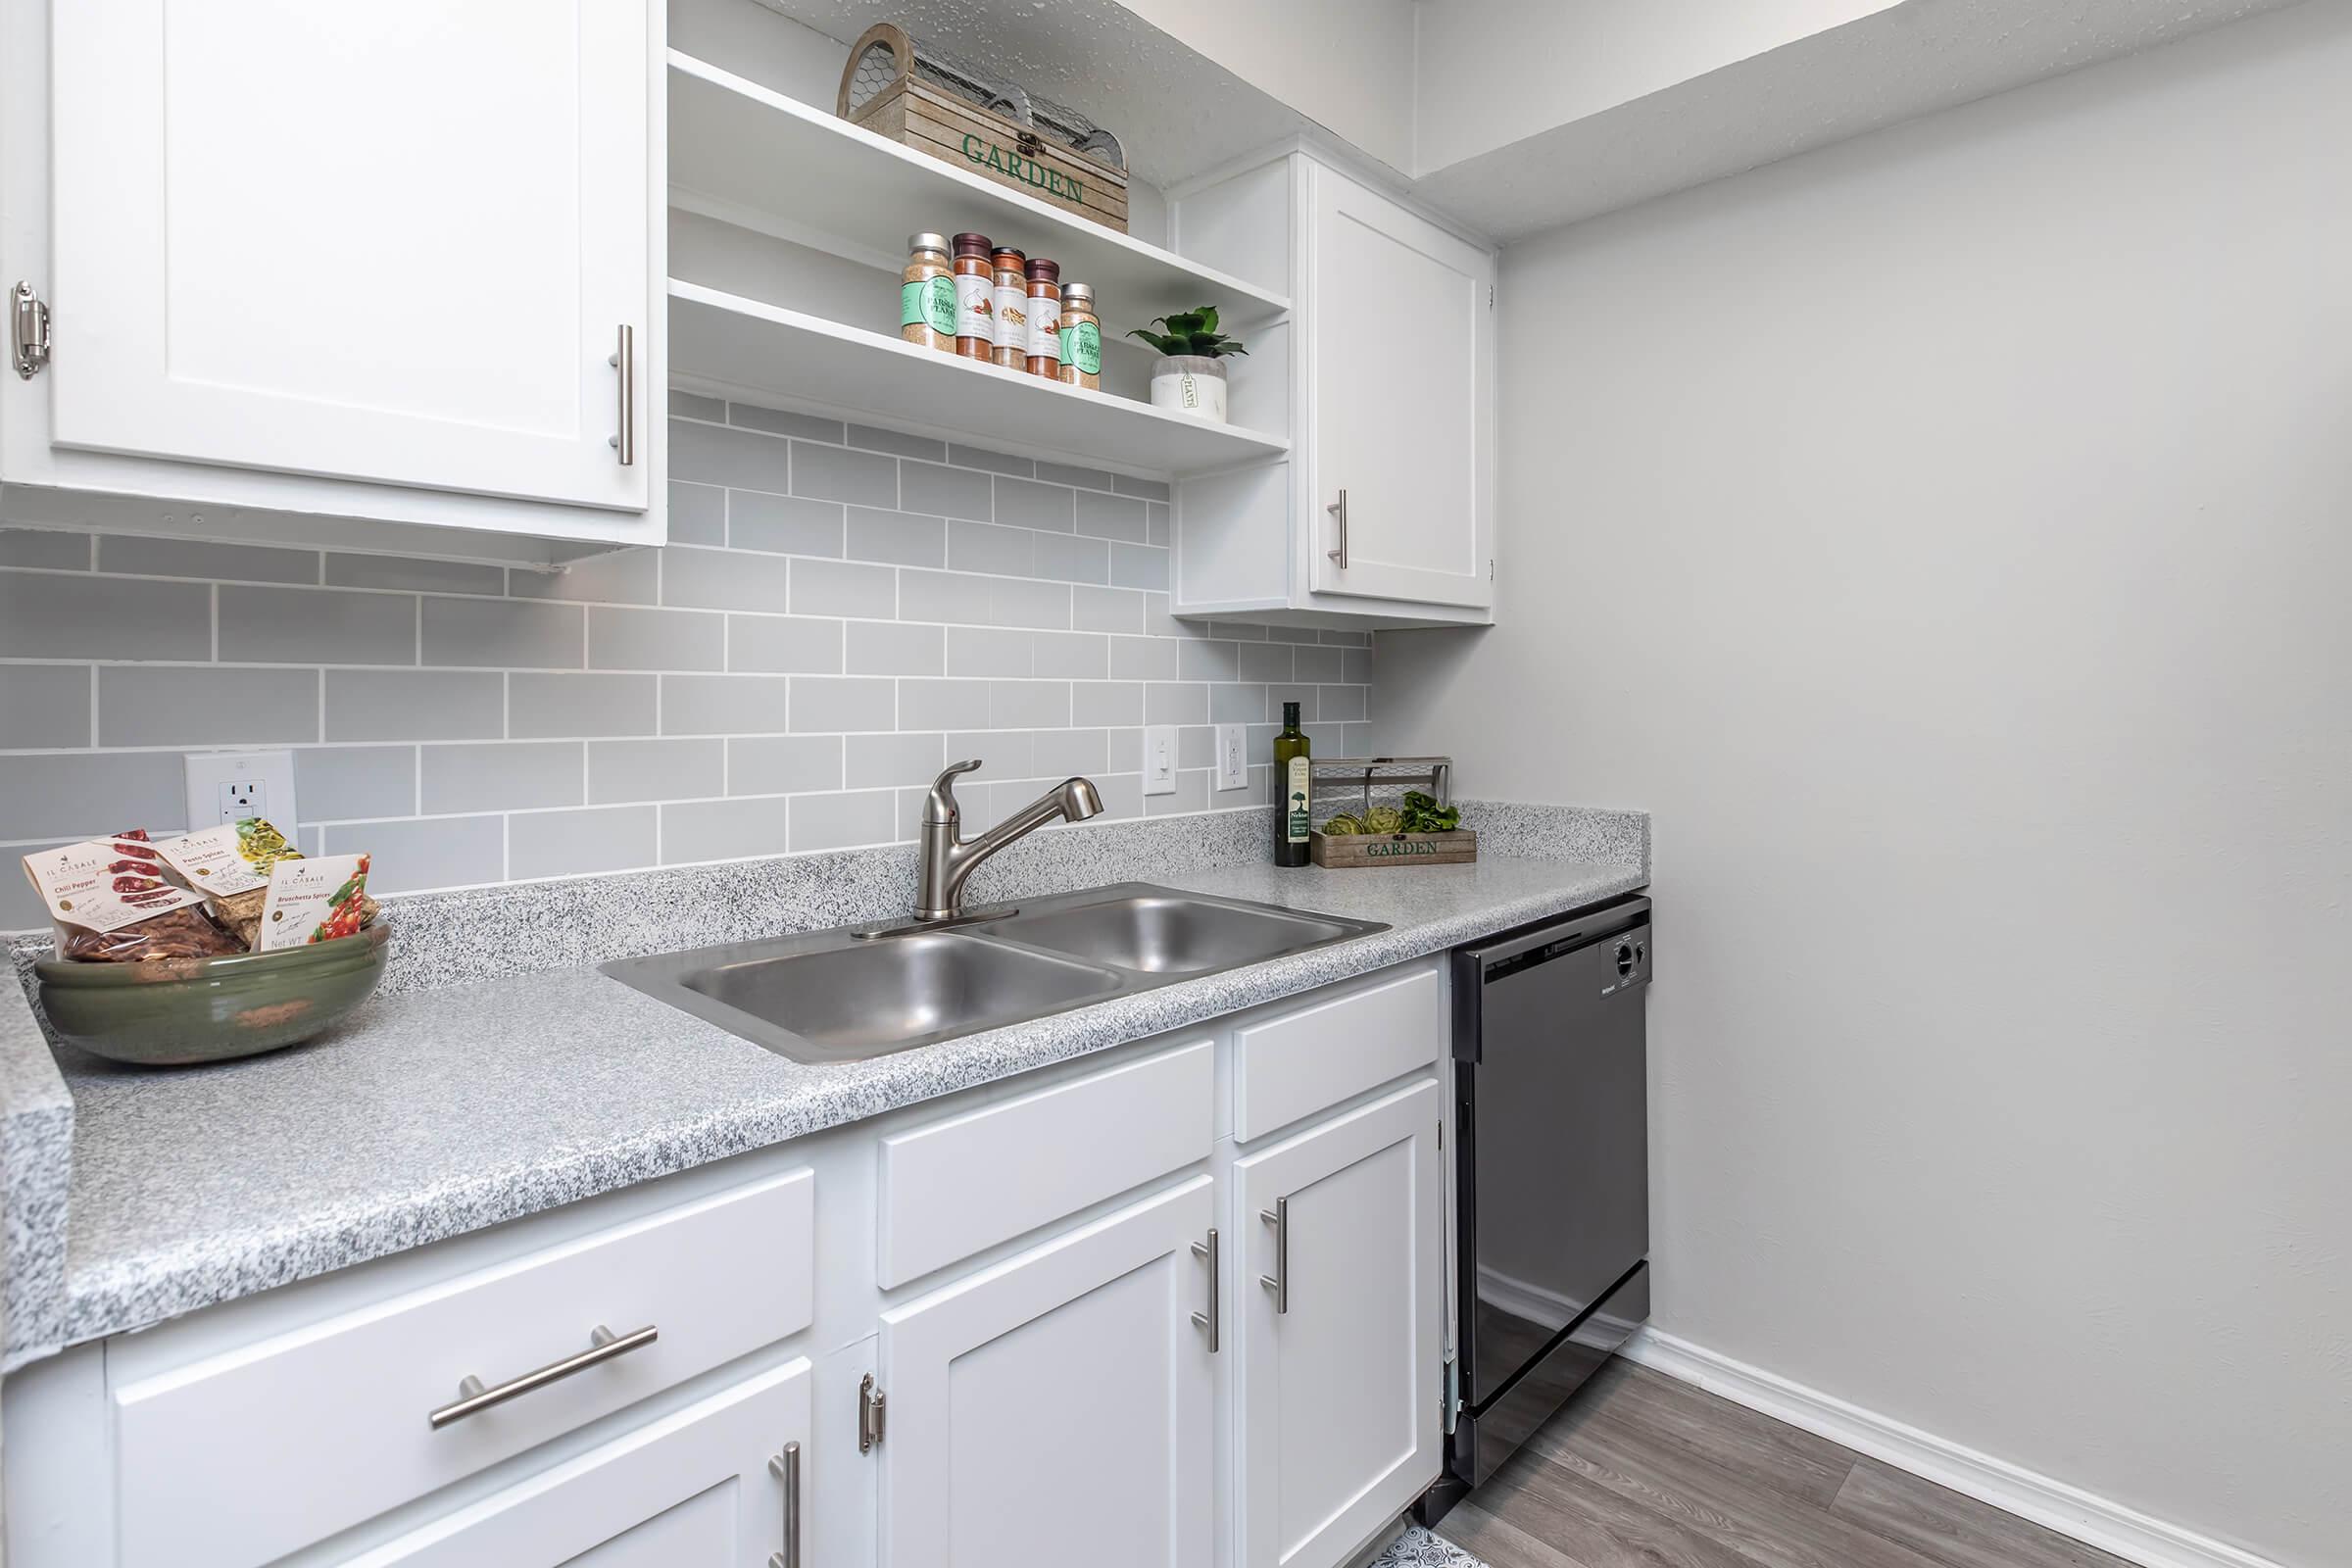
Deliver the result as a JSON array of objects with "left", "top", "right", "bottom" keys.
[{"left": 351, "top": 1361, "right": 813, "bottom": 1568}]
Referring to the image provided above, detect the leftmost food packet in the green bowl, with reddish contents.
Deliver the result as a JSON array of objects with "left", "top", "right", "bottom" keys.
[{"left": 24, "top": 827, "right": 245, "bottom": 964}]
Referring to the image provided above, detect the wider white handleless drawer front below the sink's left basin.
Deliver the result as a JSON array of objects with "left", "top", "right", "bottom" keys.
[{"left": 875, "top": 1039, "right": 1216, "bottom": 1289}]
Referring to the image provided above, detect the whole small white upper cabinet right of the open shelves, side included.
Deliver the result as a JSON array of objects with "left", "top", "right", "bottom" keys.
[{"left": 1174, "top": 153, "right": 1495, "bottom": 625}]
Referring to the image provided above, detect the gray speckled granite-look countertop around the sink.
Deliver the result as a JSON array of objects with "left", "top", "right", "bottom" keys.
[{"left": 0, "top": 807, "right": 1648, "bottom": 1363}]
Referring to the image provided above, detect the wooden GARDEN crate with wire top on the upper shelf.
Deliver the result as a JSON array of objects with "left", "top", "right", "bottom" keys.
[{"left": 835, "top": 22, "right": 1127, "bottom": 235}]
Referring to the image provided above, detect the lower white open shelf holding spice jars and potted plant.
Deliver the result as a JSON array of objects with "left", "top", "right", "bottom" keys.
[{"left": 670, "top": 277, "right": 1292, "bottom": 479}]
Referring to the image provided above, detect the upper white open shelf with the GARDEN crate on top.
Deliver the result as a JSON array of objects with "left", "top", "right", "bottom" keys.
[{"left": 670, "top": 49, "right": 1292, "bottom": 336}]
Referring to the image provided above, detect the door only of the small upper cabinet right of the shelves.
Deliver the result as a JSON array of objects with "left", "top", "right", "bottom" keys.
[{"left": 1305, "top": 165, "right": 1494, "bottom": 607}]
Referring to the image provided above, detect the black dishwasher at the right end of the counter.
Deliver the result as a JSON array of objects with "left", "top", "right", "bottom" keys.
[{"left": 1421, "top": 898, "right": 1651, "bottom": 1521}]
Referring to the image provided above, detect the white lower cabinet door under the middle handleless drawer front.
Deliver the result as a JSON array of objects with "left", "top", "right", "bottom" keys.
[{"left": 877, "top": 1175, "right": 1213, "bottom": 1568}]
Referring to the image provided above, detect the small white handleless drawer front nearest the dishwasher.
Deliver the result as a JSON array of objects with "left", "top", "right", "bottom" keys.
[{"left": 1233, "top": 966, "right": 1446, "bottom": 1143}]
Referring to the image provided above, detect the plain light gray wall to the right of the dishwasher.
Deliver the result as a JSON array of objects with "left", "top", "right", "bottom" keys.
[{"left": 1376, "top": 0, "right": 2352, "bottom": 1568}]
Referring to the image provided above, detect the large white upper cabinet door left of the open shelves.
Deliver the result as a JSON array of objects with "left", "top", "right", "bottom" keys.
[{"left": 47, "top": 0, "right": 652, "bottom": 511}]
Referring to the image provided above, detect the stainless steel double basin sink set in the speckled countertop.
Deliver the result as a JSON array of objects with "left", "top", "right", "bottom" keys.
[{"left": 605, "top": 882, "right": 1388, "bottom": 1062}]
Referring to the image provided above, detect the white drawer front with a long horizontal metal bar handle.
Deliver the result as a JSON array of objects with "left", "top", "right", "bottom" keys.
[{"left": 113, "top": 1171, "right": 816, "bottom": 1568}]
